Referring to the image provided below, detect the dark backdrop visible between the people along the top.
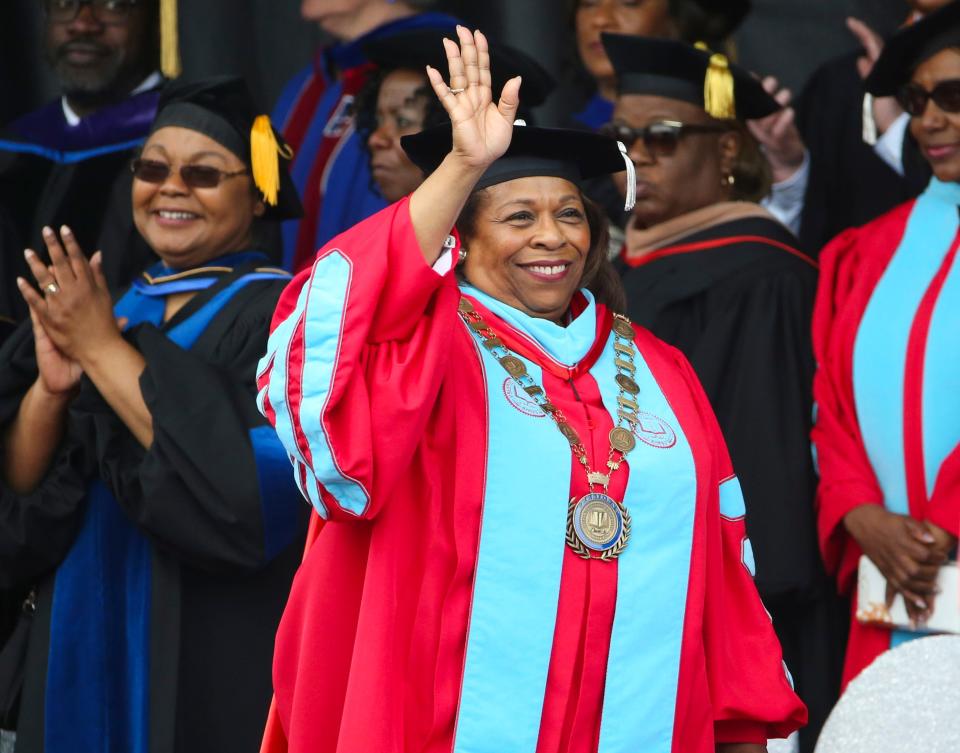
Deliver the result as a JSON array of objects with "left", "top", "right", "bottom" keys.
[{"left": 0, "top": 0, "right": 907, "bottom": 123}]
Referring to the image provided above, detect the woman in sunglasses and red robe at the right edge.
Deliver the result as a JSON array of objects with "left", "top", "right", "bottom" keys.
[{"left": 813, "top": 3, "right": 960, "bottom": 682}]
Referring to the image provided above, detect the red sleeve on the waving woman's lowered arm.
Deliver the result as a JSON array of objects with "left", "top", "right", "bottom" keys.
[{"left": 681, "top": 356, "right": 807, "bottom": 743}]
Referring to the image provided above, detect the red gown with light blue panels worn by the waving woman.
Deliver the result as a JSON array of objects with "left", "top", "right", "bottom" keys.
[{"left": 259, "top": 200, "right": 805, "bottom": 753}]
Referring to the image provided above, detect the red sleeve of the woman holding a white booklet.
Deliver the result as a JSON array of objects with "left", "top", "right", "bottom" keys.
[{"left": 812, "top": 229, "right": 883, "bottom": 591}]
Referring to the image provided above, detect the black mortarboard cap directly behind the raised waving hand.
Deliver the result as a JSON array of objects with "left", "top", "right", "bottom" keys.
[{"left": 363, "top": 28, "right": 556, "bottom": 107}]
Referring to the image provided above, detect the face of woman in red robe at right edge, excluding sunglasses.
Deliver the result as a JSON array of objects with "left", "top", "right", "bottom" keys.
[{"left": 910, "top": 49, "right": 960, "bottom": 181}]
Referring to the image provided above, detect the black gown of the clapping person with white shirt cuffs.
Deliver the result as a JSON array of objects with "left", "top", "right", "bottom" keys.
[{"left": 797, "top": 53, "right": 930, "bottom": 256}]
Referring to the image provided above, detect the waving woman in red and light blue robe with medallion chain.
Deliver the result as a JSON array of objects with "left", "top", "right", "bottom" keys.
[{"left": 259, "top": 30, "right": 805, "bottom": 753}]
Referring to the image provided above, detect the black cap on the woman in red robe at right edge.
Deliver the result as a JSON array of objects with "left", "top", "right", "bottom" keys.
[{"left": 864, "top": 2, "right": 960, "bottom": 97}]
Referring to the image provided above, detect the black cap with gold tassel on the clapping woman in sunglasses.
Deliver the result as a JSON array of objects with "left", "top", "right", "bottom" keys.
[{"left": 151, "top": 76, "right": 303, "bottom": 220}]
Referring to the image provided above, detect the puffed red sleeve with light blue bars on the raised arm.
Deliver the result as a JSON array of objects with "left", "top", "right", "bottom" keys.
[{"left": 257, "top": 199, "right": 459, "bottom": 519}]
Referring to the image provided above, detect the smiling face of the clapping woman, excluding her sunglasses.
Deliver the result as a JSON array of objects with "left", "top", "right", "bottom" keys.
[{"left": 133, "top": 126, "right": 265, "bottom": 269}]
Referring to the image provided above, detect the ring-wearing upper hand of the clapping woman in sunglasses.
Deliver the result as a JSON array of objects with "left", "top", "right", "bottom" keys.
[{"left": 24, "top": 226, "right": 120, "bottom": 366}]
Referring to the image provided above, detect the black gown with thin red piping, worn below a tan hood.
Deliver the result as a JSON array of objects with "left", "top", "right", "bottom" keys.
[{"left": 621, "top": 212, "right": 845, "bottom": 751}]
